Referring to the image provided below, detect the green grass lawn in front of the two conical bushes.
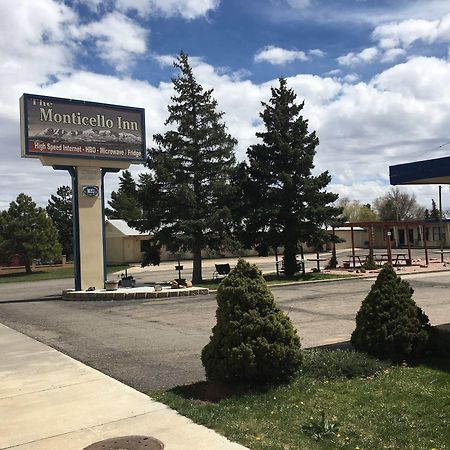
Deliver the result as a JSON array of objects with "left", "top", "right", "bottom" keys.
[{"left": 151, "top": 342, "right": 450, "bottom": 450}]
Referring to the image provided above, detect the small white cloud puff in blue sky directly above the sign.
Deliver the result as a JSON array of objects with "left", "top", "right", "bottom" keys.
[{"left": 72, "top": 12, "right": 148, "bottom": 72}]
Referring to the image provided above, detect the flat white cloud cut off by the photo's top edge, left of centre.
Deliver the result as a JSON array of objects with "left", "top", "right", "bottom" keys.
[{"left": 113, "top": 0, "right": 220, "bottom": 19}]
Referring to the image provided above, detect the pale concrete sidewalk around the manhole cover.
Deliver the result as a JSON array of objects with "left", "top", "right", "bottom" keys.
[{"left": 0, "top": 324, "right": 245, "bottom": 450}]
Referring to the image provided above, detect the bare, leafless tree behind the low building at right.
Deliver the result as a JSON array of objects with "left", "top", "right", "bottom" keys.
[{"left": 374, "top": 187, "right": 425, "bottom": 220}]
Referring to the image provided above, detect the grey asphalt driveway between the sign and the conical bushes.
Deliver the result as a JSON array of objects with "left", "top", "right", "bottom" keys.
[{"left": 0, "top": 272, "right": 450, "bottom": 391}]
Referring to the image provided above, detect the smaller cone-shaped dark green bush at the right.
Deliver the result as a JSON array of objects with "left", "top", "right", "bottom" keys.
[{"left": 351, "top": 264, "right": 430, "bottom": 361}]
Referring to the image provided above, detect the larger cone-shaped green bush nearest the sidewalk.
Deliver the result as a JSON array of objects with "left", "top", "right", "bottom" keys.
[{"left": 202, "top": 259, "right": 302, "bottom": 385}]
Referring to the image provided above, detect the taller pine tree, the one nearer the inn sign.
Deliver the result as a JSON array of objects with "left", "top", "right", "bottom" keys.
[{"left": 139, "top": 52, "right": 237, "bottom": 283}]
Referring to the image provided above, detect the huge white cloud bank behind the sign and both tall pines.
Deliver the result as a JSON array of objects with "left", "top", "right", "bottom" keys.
[{"left": 0, "top": 0, "right": 450, "bottom": 213}]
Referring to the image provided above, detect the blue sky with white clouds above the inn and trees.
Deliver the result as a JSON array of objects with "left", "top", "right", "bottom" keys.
[{"left": 0, "top": 0, "right": 450, "bottom": 209}]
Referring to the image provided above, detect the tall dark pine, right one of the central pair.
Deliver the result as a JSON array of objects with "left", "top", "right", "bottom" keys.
[{"left": 241, "top": 78, "right": 342, "bottom": 276}]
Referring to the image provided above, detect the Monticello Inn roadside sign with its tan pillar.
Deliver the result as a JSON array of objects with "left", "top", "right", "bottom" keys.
[{"left": 20, "top": 94, "right": 146, "bottom": 290}]
